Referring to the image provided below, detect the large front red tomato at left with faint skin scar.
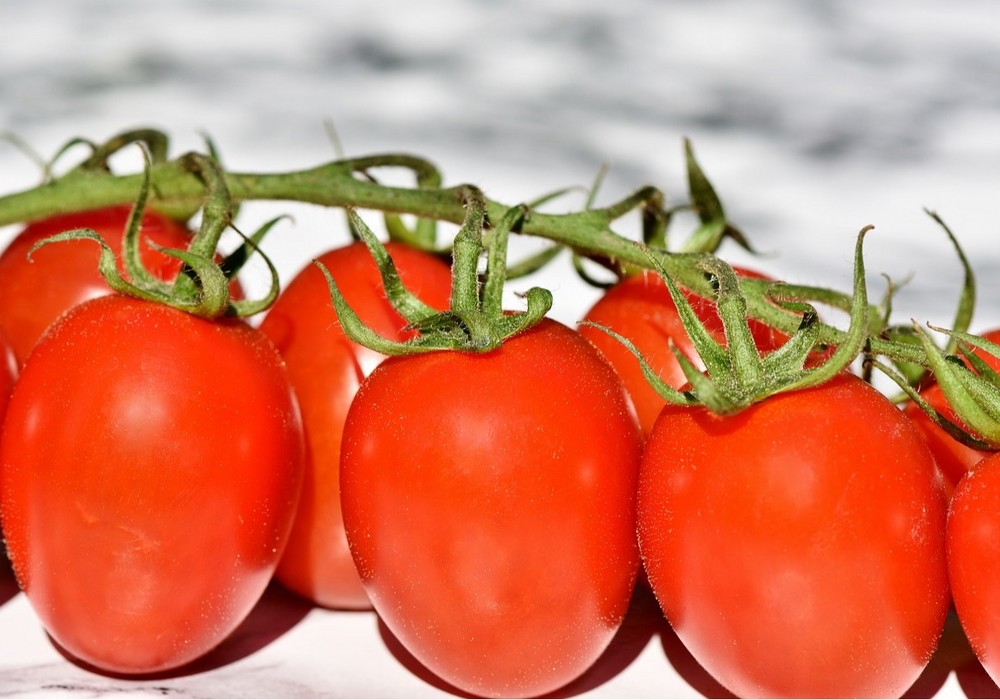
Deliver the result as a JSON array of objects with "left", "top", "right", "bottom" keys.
[{"left": 0, "top": 295, "right": 302, "bottom": 674}]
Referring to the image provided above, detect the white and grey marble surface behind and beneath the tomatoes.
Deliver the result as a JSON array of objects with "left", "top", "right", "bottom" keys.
[{"left": 0, "top": 0, "right": 1000, "bottom": 697}]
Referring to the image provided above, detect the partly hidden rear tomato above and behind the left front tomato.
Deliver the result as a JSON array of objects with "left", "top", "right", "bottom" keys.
[{"left": 0, "top": 205, "right": 241, "bottom": 365}]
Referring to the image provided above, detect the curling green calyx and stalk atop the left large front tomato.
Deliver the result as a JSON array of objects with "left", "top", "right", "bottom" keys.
[{"left": 29, "top": 132, "right": 282, "bottom": 318}]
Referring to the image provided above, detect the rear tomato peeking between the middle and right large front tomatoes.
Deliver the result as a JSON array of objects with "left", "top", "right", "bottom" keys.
[{"left": 580, "top": 268, "right": 788, "bottom": 436}]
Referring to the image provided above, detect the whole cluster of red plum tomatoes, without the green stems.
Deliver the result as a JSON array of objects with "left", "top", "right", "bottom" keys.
[{"left": 0, "top": 198, "right": 1000, "bottom": 697}]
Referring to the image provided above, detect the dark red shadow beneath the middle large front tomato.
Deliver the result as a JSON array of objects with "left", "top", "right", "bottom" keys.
[{"left": 378, "top": 587, "right": 666, "bottom": 698}]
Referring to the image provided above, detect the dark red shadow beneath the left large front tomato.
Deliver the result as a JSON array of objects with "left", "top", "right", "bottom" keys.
[{"left": 49, "top": 583, "right": 313, "bottom": 680}]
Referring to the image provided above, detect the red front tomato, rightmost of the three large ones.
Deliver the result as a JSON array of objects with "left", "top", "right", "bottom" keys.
[{"left": 638, "top": 374, "right": 949, "bottom": 697}]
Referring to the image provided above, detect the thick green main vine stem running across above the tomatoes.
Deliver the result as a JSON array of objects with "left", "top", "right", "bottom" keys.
[{"left": 0, "top": 141, "right": 927, "bottom": 365}]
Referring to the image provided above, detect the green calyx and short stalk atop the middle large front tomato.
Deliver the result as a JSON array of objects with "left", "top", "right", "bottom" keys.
[{"left": 316, "top": 187, "right": 552, "bottom": 355}]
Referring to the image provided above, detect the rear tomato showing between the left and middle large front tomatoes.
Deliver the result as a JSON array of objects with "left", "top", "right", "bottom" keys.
[{"left": 260, "top": 243, "right": 451, "bottom": 609}]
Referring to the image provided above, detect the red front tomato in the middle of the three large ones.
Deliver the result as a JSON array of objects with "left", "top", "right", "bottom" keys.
[{"left": 341, "top": 320, "right": 640, "bottom": 697}]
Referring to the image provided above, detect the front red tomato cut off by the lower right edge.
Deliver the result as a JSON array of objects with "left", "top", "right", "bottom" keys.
[{"left": 948, "top": 454, "right": 1000, "bottom": 683}]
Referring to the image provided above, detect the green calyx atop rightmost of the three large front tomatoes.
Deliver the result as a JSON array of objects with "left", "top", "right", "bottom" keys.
[{"left": 590, "top": 227, "right": 871, "bottom": 415}]
